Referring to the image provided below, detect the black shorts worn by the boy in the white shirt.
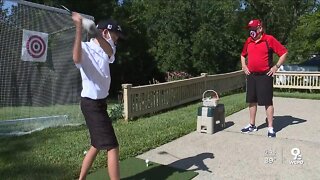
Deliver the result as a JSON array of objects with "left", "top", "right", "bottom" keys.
[{"left": 80, "top": 97, "right": 119, "bottom": 150}]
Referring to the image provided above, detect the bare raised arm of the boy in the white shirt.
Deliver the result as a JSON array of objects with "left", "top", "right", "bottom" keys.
[{"left": 72, "top": 12, "right": 82, "bottom": 64}]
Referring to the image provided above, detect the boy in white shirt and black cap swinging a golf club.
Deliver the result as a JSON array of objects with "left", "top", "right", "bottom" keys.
[{"left": 72, "top": 12, "right": 122, "bottom": 180}]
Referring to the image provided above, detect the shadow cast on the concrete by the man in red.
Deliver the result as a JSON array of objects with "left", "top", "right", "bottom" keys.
[{"left": 258, "top": 115, "right": 307, "bottom": 132}]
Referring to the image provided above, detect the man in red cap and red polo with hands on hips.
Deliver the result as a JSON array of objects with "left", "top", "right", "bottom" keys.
[{"left": 241, "top": 19, "right": 288, "bottom": 137}]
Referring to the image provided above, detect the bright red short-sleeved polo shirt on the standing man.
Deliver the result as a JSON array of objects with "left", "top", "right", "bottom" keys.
[{"left": 241, "top": 34, "right": 288, "bottom": 72}]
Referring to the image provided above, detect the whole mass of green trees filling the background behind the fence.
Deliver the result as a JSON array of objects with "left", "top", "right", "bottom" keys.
[{"left": 23, "top": 0, "right": 319, "bottom": 89}]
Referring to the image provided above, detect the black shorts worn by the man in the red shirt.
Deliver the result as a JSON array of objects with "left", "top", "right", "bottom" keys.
[{"left": 246, "top": 74, "right": 273, "bottom": 106}]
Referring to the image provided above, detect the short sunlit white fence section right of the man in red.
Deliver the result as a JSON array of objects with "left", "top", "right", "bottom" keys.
[{"left": 273, "top": 71, "right": 320, "bottom": 90}]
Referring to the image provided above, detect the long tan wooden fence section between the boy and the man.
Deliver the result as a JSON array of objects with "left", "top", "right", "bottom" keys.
[{"left": 122, "top": 71, "right": 245, "bottom": 120}]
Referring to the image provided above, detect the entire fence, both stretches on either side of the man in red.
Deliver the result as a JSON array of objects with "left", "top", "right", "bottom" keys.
[{"left": 122, "top": 71, "right": 320, "bottom": 120}]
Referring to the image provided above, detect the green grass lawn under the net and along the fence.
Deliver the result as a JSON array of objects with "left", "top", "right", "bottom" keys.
[{"left": 0, "top": 93, "right": 320, "bottom": 180}]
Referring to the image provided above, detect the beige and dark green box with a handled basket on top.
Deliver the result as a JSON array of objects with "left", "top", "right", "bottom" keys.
[{"left": 197, "top": 90, "right": 225, "bottom": 134}]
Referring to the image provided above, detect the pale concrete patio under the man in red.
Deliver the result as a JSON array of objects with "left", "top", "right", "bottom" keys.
[{"left": 138, "top": 97, "right": 320, "bottom": 180}]
